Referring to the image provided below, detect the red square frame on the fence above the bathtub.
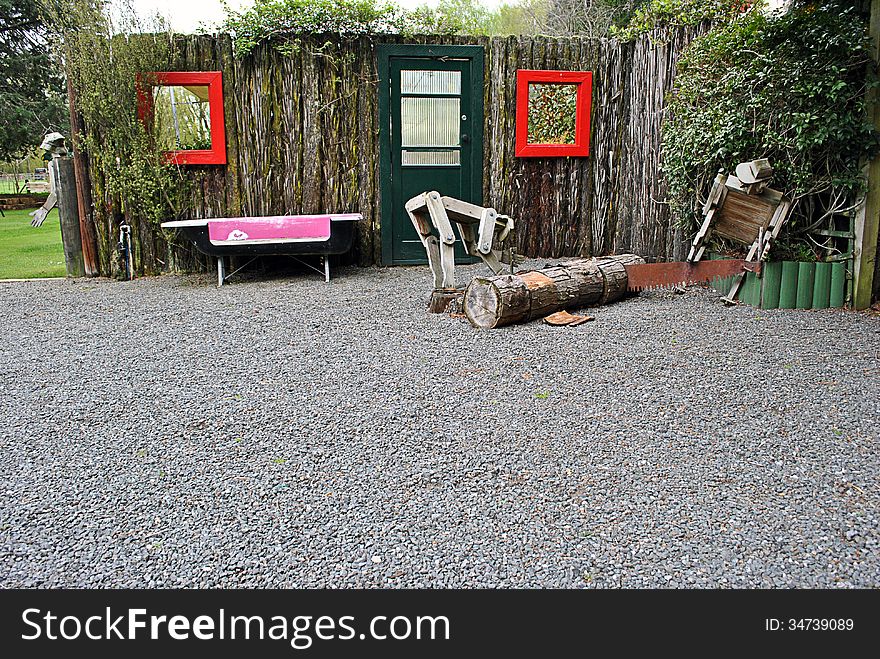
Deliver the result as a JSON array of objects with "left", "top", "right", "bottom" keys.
[{"left": 137, "top": 71, "right": 226, "bottom": 165}]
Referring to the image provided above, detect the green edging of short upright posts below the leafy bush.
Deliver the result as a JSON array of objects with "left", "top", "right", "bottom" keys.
[{"left": 709, "top": 254, "right": 846, "bottom": 309}]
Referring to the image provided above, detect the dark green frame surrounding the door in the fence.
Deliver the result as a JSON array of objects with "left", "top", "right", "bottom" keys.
[{"left": 376, "top": 44, "right": 486, "bottom": 265}]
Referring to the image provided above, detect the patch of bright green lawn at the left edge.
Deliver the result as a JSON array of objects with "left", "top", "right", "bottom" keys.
[{"left": 0, "top": 209, "right": 65, "bottom": 279}]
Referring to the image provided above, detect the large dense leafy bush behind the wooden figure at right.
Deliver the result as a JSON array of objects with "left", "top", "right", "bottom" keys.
[{"left": 662, "top": 2, "right": 876, "bottom": 244}]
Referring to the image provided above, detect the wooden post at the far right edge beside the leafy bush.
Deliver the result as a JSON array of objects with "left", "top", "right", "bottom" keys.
[{"left": 853, "top": 0, "right": 880, "bottom": 309}]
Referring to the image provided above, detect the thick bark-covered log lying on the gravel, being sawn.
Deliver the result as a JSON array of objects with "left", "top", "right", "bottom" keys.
[{"left": 464, "top": 254, "right": 645, "bottom": 329}]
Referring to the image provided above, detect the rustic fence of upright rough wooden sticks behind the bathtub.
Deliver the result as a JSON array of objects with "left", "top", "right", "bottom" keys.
[{"left": 74, "top": 28, "right": 700, "bottom": 274}]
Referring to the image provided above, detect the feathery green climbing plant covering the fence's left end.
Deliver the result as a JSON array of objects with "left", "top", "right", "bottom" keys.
[{"left": 46, "top": 0, "right": 184, "bottom": 269}]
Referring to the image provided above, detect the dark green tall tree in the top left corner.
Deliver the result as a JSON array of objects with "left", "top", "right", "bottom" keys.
[{"left": 0, "top": 0, "right": 66, "bottom": 161}]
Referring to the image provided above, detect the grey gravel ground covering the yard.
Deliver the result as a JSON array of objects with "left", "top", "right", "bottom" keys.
[{"left": 0, "top": 266, "right": 880, "bottom": 588}]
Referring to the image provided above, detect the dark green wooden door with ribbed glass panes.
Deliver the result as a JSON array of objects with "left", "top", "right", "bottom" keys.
[{"left": 379, "top": 46, "right": 483, "bottom": 264}]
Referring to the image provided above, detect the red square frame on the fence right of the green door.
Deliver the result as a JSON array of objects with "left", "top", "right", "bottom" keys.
[{"left": 516, "top": 69, "right": 593, "bottom": 158}]
